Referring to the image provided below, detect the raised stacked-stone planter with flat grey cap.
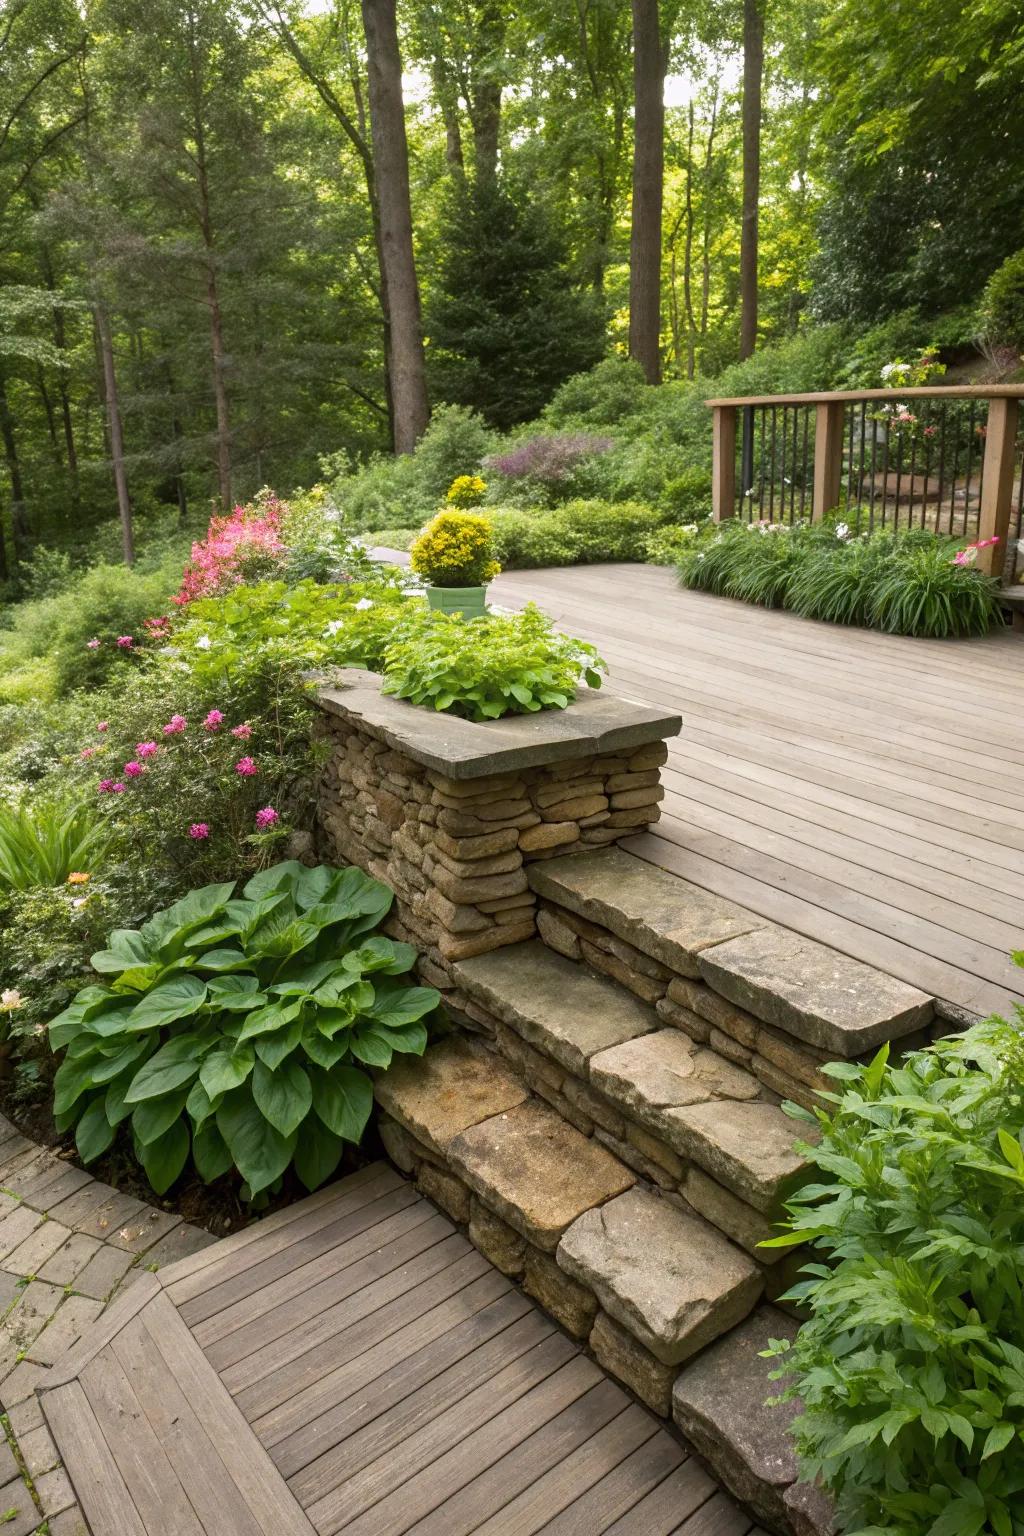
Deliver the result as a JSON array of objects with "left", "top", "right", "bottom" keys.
[{"left": 319, "top": 670, "right": 680, "bottom": 986}]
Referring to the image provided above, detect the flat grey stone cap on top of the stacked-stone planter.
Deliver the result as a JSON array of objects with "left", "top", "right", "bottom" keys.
[{"left": 316, "top": 667, "right": 683, "bottom": 779}]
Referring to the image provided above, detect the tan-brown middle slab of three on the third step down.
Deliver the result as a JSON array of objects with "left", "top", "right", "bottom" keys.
[{"left": 448, "top": 1100, "right": 634, "bottom": 1253}]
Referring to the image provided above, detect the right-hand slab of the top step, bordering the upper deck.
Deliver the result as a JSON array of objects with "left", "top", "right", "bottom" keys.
[{"left": 699, "top": 926, "right": 935, "bottom": 1058}]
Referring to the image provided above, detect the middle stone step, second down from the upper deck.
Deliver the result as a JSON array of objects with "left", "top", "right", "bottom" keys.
[{"left": 456, "top": 933, "right": 803, "bottom": 1222}]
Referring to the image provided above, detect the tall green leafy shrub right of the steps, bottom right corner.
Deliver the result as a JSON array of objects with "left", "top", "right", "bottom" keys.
[{"left": 772, "top": 983, "right": 1024, "bottom": 1536}]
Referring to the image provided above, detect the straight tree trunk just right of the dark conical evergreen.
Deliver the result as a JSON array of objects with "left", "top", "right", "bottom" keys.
[{"left": 629, "top": 0, "right": 666, "bottom": 384}]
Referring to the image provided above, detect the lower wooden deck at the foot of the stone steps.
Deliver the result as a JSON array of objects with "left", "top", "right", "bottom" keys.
[{"left": 41, "top": 1163, "right": 765, "bottom": 1536}]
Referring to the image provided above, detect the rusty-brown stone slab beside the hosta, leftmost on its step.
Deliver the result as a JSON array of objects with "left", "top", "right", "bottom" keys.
[{"left": 375, "top": 1035, "right": 528, "bottom": 1154}]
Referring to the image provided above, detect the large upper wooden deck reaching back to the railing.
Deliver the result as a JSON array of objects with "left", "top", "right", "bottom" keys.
[{"left": 493, "top": 565, "right": 1024, "bottom": 1014}]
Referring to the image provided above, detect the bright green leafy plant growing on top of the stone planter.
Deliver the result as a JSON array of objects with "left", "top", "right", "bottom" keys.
[{"left": 384, "top": 604, "right": 606, "bottom": 720}]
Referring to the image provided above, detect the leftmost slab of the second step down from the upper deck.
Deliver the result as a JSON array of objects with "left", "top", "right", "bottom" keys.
[{"left": 456, "top": 940, "right": 660, "bottom": 1077}]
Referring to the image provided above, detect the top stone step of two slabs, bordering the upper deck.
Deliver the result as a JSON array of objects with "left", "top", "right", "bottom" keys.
[{"left": 530, "top": 848, "right": 933, "bottom": 1060}]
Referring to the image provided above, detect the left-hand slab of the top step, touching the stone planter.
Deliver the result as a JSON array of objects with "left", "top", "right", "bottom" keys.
[{"left": 530, "top": 848, "right": 765, "bottom": 977}]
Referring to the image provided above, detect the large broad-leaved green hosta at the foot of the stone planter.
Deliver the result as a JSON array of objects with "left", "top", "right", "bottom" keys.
[{"left": 49, "top": 862, "right": 439, "bottom": 1200}]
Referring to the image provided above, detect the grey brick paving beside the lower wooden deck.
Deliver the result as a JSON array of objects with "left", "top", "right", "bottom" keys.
[{"left": 0, "top": 1115, "right": 215, "bottom": 1536}]
